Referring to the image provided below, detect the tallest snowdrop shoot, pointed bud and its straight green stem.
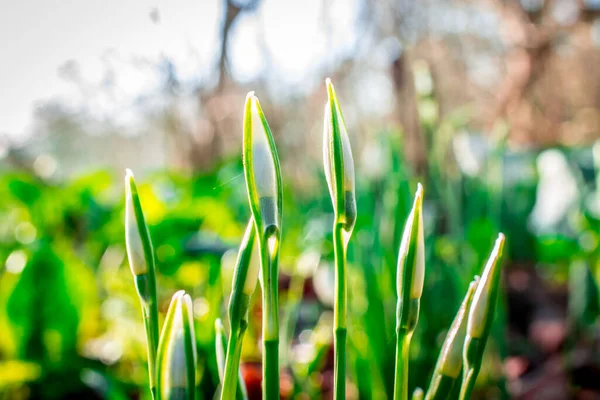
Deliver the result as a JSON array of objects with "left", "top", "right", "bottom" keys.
[{"left": 323, "top": 78, "right": 356, "bottom": 400}]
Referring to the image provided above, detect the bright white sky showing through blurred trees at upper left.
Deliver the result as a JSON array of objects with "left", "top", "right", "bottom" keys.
[{"left": 0, "top": 0, "right": 356, "bottom": 137}]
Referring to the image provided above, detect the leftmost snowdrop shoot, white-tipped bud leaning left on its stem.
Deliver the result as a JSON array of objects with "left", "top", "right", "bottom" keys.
[{"left": 125, "top": 169, "right": 159, "bottom": 398}]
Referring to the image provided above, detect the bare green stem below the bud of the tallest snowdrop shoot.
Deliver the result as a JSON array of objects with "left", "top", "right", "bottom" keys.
[{"left": 333, "top": 223, "right": 347, "bottom": 400}]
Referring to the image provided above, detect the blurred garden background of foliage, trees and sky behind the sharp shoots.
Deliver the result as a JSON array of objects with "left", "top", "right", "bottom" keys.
[{"left": 0, "top": 0, "right": 600, "bottom": 399}]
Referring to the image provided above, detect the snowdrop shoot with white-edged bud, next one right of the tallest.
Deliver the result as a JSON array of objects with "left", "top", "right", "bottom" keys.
[{"left": 394, "top": 183, "right": 425, "bottom": 400}]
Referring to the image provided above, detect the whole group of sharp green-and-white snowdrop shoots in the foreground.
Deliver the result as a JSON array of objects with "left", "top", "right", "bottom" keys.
[{"left": 125, "top": 79, "right": 504, "bottom": 400}]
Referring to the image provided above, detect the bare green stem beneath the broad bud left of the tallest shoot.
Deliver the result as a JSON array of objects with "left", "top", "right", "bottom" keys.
[{"left": 260, "top": 232, "right": 279, "bottom": 400}]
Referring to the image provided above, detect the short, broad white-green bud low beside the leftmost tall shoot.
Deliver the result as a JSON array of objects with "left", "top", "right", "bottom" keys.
[{"left": 156, "top": 290, "right": 197, "bottom": 400}]
